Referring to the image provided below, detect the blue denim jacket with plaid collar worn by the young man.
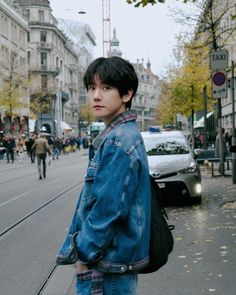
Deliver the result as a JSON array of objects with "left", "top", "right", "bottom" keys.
[{"left": 59, "top": 111, "right": 151, "bottom": 273}]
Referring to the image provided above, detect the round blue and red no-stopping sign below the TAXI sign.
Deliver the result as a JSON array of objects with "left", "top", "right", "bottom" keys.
[{"left": 212, "top": 70, "right": 227, "bottom": 98}]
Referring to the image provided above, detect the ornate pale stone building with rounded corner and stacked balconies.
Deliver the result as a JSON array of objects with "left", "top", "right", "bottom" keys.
[{"left": 7, "top": 0, "right": 78, "bottom": 136}]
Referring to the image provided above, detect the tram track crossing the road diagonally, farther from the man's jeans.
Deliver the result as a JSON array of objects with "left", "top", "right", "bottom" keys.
[{"left": 0, "top": 180, "right": 84, "bottom": 238}]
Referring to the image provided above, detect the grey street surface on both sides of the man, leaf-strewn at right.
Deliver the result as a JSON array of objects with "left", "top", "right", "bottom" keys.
[{"left": 0, "top": 150, "right": 236, "bottom": 295}]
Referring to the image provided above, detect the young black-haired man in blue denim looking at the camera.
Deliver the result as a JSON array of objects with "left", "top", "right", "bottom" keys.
[{"left": 57, "top": 57, "right": 151, "bottom": 295}]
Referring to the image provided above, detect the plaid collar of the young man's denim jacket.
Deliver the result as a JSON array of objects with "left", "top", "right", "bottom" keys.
[{"left": 92, "top": 110, "right": 137, "bottom": 150}]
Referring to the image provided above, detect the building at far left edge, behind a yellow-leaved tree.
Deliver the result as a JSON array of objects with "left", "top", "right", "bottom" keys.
[{"left": 0, "top": 0, "right": 29, "bottom": 134}]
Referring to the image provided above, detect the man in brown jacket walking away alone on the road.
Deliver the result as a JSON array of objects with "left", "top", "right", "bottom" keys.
[{"left": 31, "top": 135, "right": 52, "bottom": 179}]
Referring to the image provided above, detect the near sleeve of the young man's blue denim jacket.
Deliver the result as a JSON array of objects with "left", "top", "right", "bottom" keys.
[{"left": 76, "top": 144, "right": 138, "bottom": 263}]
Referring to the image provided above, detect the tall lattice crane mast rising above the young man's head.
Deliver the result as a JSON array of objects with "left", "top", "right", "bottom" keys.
[{"left": 102, "top": 0, "right": 111, "bottom": 57}]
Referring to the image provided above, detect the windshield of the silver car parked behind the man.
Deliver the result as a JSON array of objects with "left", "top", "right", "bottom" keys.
[{"left": 144, "top": 137, "right": 189, "bottom": 156}]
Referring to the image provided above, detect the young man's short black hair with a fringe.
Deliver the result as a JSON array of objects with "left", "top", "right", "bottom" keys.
[{"left": 84, "top": 56, "right": 138, "bottom": 109}]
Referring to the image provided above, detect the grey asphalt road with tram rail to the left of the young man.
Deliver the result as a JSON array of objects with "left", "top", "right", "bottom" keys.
[{"left": 0, "top": 153, "right": 87, "bottom": 295}]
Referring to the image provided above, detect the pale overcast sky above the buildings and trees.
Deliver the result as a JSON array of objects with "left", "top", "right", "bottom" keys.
[{"left": 50, "top": 0, "right": 195, "bottom": 76}]
